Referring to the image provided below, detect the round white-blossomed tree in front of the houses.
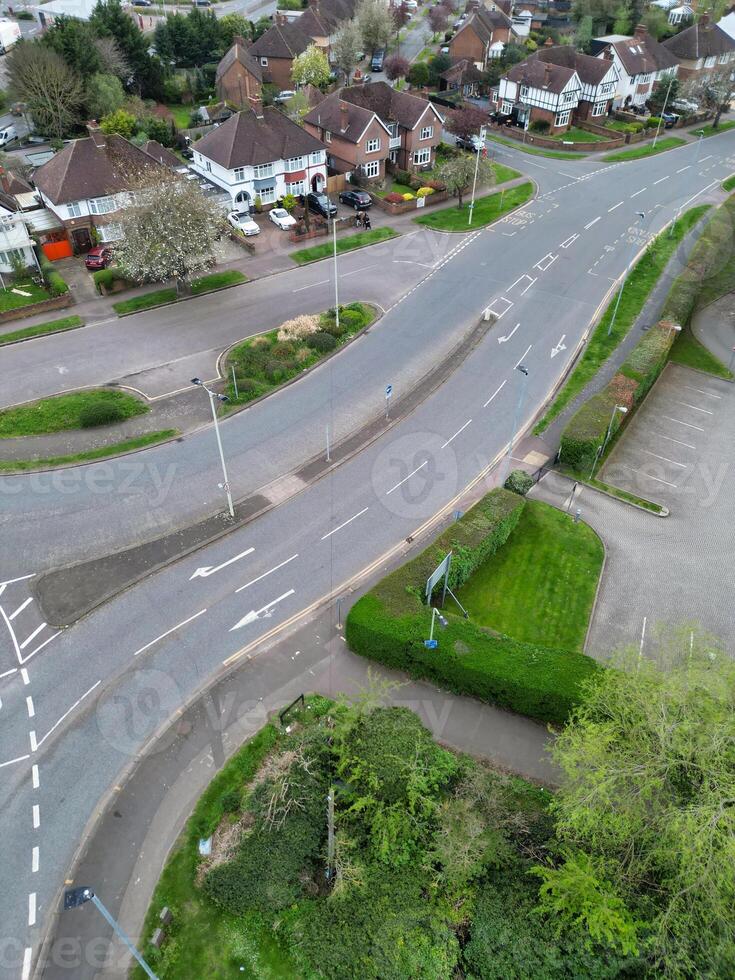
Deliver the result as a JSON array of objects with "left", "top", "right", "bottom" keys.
[{"left": 115, "top": 168, "right": 225, "bottom": 294}]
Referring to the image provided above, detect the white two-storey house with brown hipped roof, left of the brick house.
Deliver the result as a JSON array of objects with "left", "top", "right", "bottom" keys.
[{"left": 191, "top": 100, "right": 327, "bottom": 210}]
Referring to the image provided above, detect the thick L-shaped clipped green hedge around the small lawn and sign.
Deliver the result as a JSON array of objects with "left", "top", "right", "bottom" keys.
[{"left": 345, "top": 489, "right": 599, "bottom": 725}]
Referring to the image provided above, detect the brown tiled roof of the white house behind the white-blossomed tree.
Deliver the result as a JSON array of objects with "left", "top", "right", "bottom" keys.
[{"left": 33, "top": 133, "right": 156, "bottom": 204}]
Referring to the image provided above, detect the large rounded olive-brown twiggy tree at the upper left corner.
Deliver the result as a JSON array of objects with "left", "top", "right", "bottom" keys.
[{"left": 5, "top": 41, "right": 83, "bottom": 138}]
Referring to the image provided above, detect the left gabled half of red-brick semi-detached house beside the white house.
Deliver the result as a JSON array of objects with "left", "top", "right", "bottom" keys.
[{"left": 304, "top": 92, "right": 391, "bottom": 183}]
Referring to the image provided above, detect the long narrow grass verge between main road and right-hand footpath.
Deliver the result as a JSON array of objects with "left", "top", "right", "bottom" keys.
[{"left": 533, "top": 204, "right": 709, "bottom": 435}]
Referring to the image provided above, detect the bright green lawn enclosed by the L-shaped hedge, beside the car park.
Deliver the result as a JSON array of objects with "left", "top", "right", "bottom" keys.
[{"left": 458, "top": 500, "right": 604, "bottom": 650}]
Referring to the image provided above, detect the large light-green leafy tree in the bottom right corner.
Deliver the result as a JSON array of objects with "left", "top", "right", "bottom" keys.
[{"left": 536, "top": 630, "right": 735, "bottom": 980}]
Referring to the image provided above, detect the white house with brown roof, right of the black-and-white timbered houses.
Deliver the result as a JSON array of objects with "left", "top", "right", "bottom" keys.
[{"left": 592, "top": 24, "right": 678, "bottom": 109}]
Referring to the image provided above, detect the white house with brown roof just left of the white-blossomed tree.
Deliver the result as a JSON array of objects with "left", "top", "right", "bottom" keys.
[{"left": 33, "top": 123, "right": 160, "bottom": 253}]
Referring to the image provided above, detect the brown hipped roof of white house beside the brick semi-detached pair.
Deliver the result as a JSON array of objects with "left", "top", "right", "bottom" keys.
[{"left": 194, "top": 106, "right": 324, "bottom": 170}]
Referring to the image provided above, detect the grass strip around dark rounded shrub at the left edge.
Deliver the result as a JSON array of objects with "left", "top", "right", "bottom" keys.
[{"left": 0, "top": 388, "right": 149, "bottom": 439}]
